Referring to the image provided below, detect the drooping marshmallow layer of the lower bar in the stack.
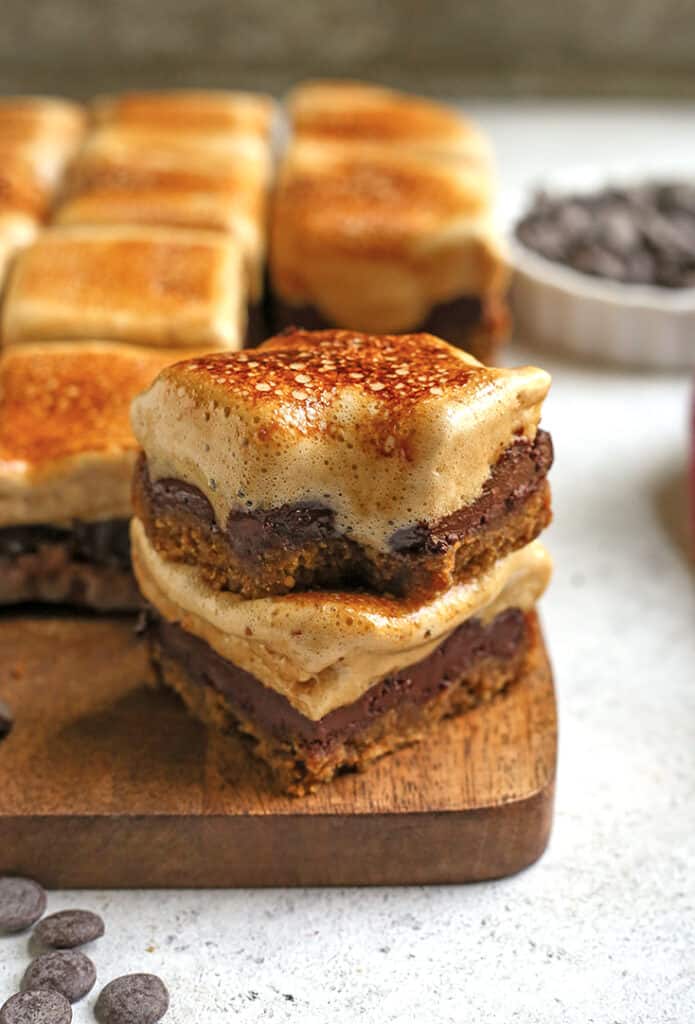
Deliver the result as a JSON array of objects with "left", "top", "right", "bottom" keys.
[{"left": 131, "top": 519, "right": 551, "bottom": 721}]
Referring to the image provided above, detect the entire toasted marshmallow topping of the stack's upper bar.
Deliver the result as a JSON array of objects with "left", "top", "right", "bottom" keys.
[{"left": 132, "top": 331, "right": 550, "bottom": 551}]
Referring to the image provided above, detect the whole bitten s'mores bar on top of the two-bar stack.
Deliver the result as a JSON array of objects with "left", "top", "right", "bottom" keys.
[{"left": 132, "top": 330, "right": 552, "bottom": 598}]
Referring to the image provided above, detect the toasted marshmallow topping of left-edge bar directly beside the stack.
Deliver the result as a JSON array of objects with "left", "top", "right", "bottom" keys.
[{"left": 0, "top": 342, "right": 182, "bottom": 527}]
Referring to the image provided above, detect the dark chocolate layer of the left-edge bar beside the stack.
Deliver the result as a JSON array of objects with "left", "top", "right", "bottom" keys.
[{"left": 0, "top": 519, "right": 130, "bottom": 571}]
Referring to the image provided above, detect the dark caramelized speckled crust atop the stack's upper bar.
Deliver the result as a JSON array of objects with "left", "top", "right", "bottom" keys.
[{"left": 158, "top": 330, "right": 495, "bottom": 457}]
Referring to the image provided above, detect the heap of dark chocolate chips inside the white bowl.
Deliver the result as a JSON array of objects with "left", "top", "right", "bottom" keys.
[{"left": 516, "top": 182, "right": 695, "bottom": 288}]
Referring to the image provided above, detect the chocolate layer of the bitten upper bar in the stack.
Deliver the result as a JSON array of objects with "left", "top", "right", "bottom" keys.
[{"left": 137, "top": 430, "right": 553, "bottom": 561}]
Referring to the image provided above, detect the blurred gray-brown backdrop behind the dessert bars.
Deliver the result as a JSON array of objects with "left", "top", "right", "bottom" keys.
[{"left": 0, "top": 0, "right": 695, "bottom": 97}]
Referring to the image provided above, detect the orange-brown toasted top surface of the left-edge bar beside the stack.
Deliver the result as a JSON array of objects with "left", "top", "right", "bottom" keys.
[{"left": 0, "top": 344, "right": 171, "bottom": 469}]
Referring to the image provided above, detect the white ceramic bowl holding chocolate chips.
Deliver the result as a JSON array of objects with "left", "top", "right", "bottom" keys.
[{"left": 505, "top": 160, "right": 695, "bottom": 370}]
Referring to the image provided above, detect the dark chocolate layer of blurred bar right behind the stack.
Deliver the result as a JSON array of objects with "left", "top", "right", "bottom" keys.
[{"left": 272, "top": 295, "right": 509, "bottom": 362}]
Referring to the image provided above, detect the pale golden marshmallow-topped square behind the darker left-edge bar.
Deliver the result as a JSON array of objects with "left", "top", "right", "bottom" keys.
[{"left": 2, "top": 225, "right": 248, "bottom": 349}]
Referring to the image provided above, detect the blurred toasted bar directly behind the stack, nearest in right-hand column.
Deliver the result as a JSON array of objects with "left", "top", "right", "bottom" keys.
[{"left": 270, "top": 137, "right": 509, "bottom": 362}]
